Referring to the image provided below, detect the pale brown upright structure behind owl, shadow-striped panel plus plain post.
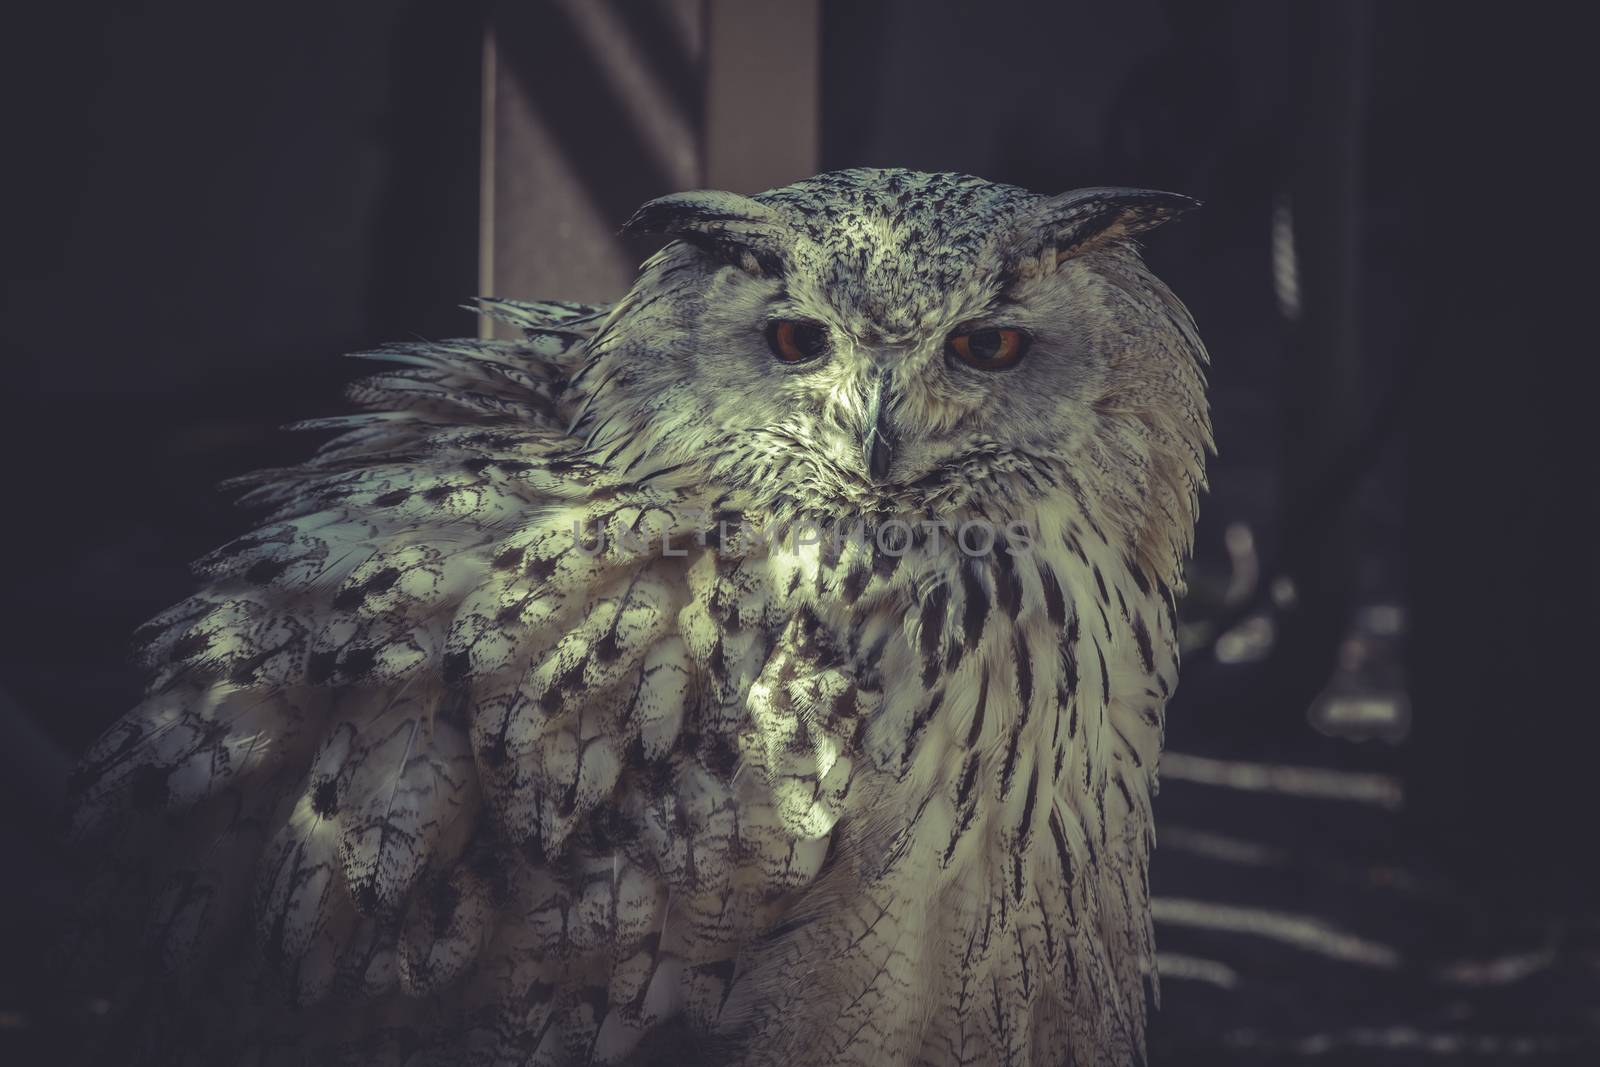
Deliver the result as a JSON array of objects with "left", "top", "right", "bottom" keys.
[{"left": 478, "top": 0, "right": 822, "bottom": 336}]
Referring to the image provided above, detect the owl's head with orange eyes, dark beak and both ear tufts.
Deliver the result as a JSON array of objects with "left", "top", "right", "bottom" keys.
[{"left": 586, "top": 170, "right": 1210, "bottom": 585}]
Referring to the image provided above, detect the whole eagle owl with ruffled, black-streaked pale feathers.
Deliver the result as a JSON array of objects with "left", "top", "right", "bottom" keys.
[{"left": 74, "top": 170, "right": 1211, "bottom": 1067}]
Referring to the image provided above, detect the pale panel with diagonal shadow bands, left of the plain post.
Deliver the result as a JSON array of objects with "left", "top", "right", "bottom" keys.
[{"left": 478, "top": 0, "right": 706, "bottom": 331}]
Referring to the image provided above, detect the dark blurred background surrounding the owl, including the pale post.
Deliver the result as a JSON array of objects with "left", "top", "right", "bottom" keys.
[{"left": 0, "top": 0, "right": 1600, "bottom": 1064}]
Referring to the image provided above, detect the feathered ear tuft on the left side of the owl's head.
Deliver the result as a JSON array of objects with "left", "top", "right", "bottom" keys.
[{"left": 622, "top": 189, "right": 790, "bottom": 277}]
